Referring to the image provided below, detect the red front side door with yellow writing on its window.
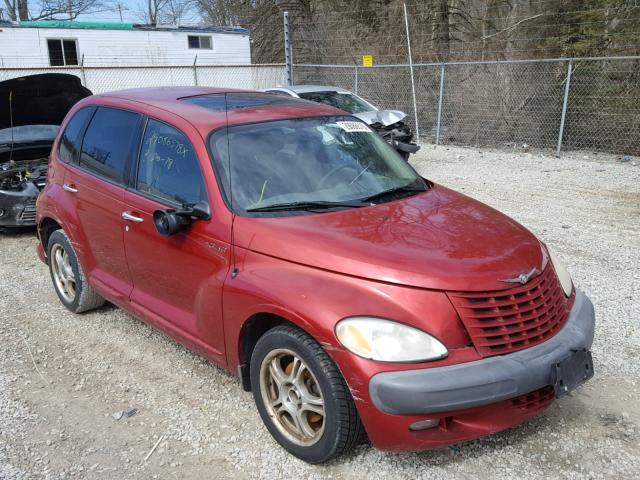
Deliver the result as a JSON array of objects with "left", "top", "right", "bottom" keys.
[{"left": 122, "top": 118, "right": 230, "bottom": 363}]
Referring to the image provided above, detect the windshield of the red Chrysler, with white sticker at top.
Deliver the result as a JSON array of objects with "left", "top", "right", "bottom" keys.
[{"left": 210, "top": 116, "right": 425, "bottom": 215}]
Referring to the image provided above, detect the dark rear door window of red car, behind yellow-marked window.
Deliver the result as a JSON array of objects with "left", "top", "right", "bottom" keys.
[{"left": 80, "top": 107, "right": 140, "bottom": 183}]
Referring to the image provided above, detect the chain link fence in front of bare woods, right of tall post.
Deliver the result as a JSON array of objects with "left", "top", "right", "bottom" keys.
[{"left": 294, "top": 57, "right": 640, "bottom": 155}]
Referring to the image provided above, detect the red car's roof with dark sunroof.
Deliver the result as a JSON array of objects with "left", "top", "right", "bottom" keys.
[{"left": 87, "top": 87, "right": 345, "bottom": 137}]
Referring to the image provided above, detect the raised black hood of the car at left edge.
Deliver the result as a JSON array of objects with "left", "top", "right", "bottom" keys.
[{"left": 0, "top": 73, "right": 92, "bottom": 130}]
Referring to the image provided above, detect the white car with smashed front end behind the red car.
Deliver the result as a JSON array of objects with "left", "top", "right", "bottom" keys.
[{"left": 263, "top": 85, "right": 420, "bottom": 160}]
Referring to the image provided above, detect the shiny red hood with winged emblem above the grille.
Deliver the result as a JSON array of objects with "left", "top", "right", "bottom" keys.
[{"left": 234, "top": 185, "right": 547, "bottom": 291}]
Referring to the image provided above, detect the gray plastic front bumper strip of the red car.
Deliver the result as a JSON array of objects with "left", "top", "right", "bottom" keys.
[{"left": 369, "top": 290, "right": 595, "bottom": 415}]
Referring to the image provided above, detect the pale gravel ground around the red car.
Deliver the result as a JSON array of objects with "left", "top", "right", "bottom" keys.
[{"left": 0, "top": 146, "right": 640, "bottom": 479}]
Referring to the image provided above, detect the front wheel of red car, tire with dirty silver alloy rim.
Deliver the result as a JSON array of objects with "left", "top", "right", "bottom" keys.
[{"left": 251, "top": 326, "right": 363, "bottom": 463}]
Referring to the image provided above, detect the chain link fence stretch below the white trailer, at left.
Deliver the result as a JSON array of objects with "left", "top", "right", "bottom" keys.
[{"left": 0, "top": 64, "right": 285, "bottom": 94}]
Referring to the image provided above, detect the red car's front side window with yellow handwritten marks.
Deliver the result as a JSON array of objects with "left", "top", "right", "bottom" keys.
[{"left": 136, "top": 119, "right": 207, "bottom": 205}]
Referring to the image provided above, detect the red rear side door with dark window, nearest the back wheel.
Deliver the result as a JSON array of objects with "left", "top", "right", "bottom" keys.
[{"left": 61, "top": 107, "right": 142, "bottom": 303}]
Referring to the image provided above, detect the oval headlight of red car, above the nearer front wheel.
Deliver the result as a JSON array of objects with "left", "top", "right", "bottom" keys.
[{"left": 336, "top": 317, "right": 448, "bottom": 362}]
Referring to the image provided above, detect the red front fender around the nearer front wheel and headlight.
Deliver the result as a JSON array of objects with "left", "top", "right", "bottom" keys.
[{"left": 223, "top": 247, "right": 478, "bottom": 403}]
